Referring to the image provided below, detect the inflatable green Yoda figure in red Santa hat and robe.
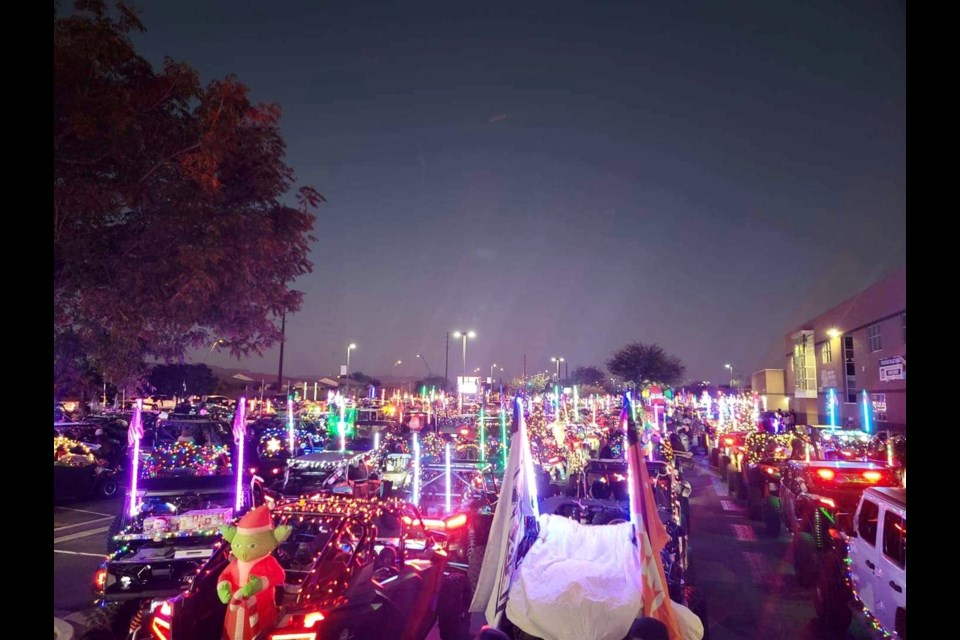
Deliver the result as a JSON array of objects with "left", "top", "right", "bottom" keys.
[{"left": 217, "top": 505, "right": 291, "bottom": 640}]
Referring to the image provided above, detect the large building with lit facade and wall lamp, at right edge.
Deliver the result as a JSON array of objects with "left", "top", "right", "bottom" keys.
[{"left": 785, "top": 269, "right": 907, "bottom": 432}]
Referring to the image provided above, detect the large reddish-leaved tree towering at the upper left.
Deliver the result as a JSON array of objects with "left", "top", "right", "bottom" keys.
[{"left": 53, "top": 0, "right": 323, "bottom": 396}]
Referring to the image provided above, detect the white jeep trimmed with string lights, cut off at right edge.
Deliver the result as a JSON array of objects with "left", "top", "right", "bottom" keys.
[{"left": 813, "top": 487, "right": 907, "bottom": 640}]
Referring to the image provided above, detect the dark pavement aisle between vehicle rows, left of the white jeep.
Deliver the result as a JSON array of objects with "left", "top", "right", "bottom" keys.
[{"left": 686, "top": 460, "right": 870, "bottom": 640}]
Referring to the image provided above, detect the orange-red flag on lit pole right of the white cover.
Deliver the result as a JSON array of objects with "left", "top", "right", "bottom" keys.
[{"left": 620, "top": 395, "right": 683, "bottom": 640}]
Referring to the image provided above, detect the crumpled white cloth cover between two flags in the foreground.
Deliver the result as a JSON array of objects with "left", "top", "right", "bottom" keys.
[{"left": 506, "top": 514, "right": 703, "bottom": 640}]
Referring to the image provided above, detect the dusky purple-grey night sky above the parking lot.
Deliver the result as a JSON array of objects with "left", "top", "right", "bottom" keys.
[{"left": 136, "top": 0, "right": 906, "bottom": 382}]
